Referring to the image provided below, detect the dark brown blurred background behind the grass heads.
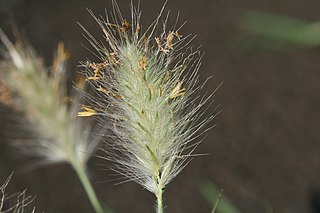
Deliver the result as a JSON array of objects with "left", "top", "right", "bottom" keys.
[{"left": 0, "top": 0, "right": 320, "bottom": 213}]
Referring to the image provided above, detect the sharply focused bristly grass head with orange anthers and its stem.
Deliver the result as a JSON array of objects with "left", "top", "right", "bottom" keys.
[{"left": 78, "top": 1, "right": 214, "bottom": 213}]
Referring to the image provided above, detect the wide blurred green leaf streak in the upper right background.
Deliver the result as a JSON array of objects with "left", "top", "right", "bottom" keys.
[{"left": 239, "top": 11, "right": 320, "bottom": 48}]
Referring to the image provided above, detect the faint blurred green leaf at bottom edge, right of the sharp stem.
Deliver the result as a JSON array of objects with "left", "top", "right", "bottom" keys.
[{"left": 200, "top": 181, "right": 240, "bottom": 213}]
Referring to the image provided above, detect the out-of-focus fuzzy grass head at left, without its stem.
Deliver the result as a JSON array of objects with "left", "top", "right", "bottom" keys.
[{"left": 0, "top": 29, "right": 98, "bottom": 165}]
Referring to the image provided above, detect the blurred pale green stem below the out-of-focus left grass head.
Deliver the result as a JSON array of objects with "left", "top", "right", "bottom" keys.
[{"left": 72, "top": 160, "right": 104, "bottom": 213}]
